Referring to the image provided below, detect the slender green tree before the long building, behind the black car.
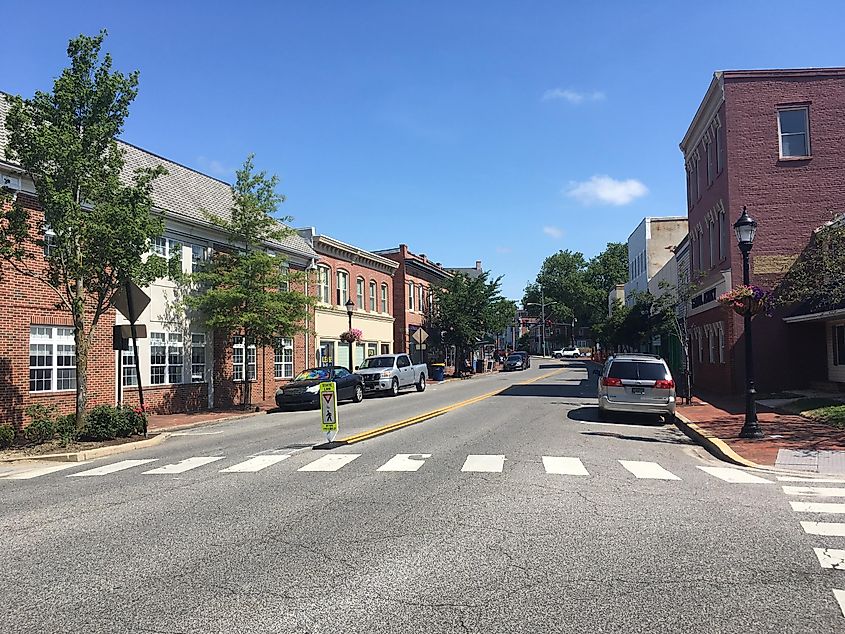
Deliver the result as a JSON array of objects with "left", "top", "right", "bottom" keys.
[{"left": 185, "top": 155, "right": 313, "bottom": 408}]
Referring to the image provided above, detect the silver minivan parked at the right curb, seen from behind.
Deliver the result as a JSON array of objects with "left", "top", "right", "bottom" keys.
[{"left": 595, "top": 354, "right": 675, "bottom": 422}]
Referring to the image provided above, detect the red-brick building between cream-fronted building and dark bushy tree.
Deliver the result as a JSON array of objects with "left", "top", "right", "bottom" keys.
[{"left": 374, "top": 244, "right": 452, "bottom": 363}]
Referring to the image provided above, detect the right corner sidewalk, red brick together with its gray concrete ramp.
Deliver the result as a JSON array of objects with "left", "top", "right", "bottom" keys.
[{"left": 678, "top": 396, "right": 845, "bottom": 474}]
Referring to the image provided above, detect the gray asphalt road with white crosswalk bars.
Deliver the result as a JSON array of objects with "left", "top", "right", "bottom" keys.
[{"left": 0, "top": 360, "right": 845, "bottom": 634}]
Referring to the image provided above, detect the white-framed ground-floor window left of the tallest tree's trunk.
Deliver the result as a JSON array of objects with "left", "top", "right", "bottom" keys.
[{"left": 29, "top": 326, "right": 76, "bottom": 392}]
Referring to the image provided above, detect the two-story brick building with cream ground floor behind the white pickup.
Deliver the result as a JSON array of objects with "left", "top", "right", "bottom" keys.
[{"left": 299, "top": 228, "right": 399, "bottom": 369}]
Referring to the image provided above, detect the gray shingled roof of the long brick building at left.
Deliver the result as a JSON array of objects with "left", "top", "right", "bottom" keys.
[{"left": 0, "top": 92, "right": 317, "bottom": 257}]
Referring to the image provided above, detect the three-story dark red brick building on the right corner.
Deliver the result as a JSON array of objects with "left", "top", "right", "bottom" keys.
[{"left": 680, "top": 68, "right": 845, "bottom": 392}]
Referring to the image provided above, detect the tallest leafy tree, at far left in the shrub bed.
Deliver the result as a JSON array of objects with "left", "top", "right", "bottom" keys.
[{"left": 0, "top": 31, "right": 164, "bottom": 428}]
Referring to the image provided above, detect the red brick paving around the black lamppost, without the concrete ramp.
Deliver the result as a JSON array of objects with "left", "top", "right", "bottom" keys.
[{"left": 678, "top": 396, "right": 845, "bottom": 466}]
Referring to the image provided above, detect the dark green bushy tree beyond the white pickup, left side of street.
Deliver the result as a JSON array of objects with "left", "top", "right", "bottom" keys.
[{"left": 430, "top": 271, "right": 502, "bottom": 372}]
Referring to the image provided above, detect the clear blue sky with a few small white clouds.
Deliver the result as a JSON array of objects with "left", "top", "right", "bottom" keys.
[{"left": 0, "top": 0, "right": 845, "bottom": 298}]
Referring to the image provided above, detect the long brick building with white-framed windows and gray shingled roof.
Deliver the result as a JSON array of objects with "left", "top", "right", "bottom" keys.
[{"left": 0, "top": 98, "right": 316, "bottom": 425}]
